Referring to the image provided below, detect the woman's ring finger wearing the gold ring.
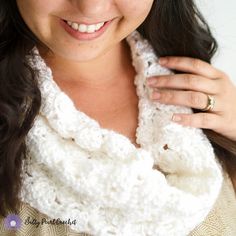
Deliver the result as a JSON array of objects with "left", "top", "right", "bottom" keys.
[{"left": 151, "top": 89, "right": 222, "bottom": 113}]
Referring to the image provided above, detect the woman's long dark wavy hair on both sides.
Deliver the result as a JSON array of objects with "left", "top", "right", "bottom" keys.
[{"left": 0, "top": 0, "right": 236, "bottom": 216}]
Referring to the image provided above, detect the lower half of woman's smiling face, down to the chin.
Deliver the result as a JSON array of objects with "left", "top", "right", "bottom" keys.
[{"left": 16, "top": 0, "right": 154, "bottom": 62}]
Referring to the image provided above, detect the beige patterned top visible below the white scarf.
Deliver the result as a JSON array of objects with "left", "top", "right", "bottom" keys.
[{"left": 0, "top": 171, "right": 236, "bottom": 236}]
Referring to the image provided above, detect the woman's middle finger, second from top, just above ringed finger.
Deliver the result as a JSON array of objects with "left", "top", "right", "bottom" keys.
[{"left": 147, "top": 74, "right": 220, "bottom": 94}]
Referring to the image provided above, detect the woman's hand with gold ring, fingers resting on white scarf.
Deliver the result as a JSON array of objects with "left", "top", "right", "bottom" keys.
[{"left": 148, "top": 57, "right": 236, "bottom": 140}]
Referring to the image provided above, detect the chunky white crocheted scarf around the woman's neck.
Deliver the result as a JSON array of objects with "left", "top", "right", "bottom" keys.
[{"left": 21, "top": 31, "right": 223, "bottom": 236}]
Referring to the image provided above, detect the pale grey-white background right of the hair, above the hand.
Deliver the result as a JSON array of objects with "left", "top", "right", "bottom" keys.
[{"left": 196, "top": 0, "right": 236, "bottom": 85}]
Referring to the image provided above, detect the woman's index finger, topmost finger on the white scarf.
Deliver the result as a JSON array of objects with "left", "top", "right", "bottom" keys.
[{"left": 159, "top": 56, "right": 225, "bottom": 79}]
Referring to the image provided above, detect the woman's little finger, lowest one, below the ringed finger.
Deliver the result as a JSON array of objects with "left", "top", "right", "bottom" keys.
[{"left": 172, "top": 112, "right": 222, "bottom": 132}]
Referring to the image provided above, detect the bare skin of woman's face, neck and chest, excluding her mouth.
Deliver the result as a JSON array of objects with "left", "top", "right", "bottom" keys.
[{"left": 17, "top": 0, "right": 154, "bottom": 146}]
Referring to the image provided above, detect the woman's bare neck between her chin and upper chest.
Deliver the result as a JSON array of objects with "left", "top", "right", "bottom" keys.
[{"left": 36, "top": 40, "right": 134, "bottom": 90}]
